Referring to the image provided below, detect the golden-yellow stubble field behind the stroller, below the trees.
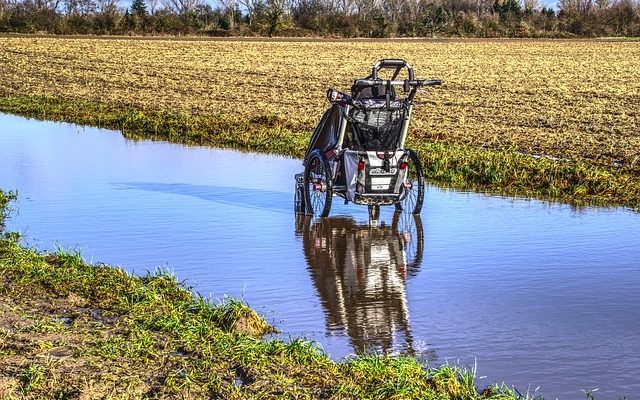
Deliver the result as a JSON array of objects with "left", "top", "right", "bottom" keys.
[{"left": 0, "top": 38, "right": 640, "bottom": 202}]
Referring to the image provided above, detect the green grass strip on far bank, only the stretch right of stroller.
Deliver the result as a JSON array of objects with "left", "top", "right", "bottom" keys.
[{"left": 412, "top": 142, "right": 640, "bottom": 209}]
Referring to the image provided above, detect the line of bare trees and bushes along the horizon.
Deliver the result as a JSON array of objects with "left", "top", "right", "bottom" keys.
[{"left": 0, "top": 0, "right": 640, "bottom": 37}]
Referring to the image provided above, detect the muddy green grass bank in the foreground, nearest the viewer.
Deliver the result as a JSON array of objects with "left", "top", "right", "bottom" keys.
[{"left": 0, "top": 190, "right": 529, "bottom": 399}]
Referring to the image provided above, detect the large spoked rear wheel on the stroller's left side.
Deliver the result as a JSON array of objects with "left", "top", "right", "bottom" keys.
[{"left": 304, "top": 149, "right": 333, "bottom": 217}]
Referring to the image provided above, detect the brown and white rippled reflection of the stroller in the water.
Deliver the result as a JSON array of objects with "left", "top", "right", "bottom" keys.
[{"left": 296, "top": 213, "right": 434, "bottom": 358}]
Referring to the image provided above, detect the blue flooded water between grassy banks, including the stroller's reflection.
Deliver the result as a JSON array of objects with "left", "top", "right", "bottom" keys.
[{"left": 0, "top": 114, "right": 640, "bottom": 399}]
